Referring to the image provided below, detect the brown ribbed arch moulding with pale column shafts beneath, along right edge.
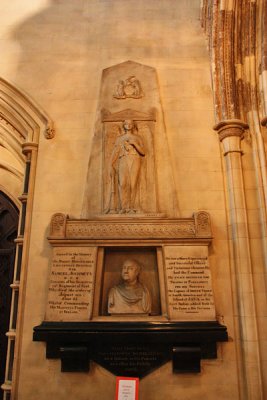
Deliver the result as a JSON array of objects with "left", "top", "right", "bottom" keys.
[{"left": 202, "top": 0, "right": 267, "bottom": 400}]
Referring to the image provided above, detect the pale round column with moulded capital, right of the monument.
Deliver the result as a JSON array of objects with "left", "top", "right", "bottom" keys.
[{"left": 214, "top": 119, "right": 262, "bottom": 399}]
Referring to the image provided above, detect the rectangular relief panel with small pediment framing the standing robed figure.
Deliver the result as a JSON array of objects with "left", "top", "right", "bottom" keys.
[{"left": 103, "top": 110, "right": 157, "bottom": 214}]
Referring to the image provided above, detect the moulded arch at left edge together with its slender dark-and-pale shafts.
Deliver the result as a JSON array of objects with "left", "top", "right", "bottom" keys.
[{"left": 0, "top": 77, "right": 55, "bottom": 400}]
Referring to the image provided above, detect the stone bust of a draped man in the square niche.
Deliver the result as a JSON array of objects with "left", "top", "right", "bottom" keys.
[{"left": 108, "top": 259, "right": 151, "bottom": 314}]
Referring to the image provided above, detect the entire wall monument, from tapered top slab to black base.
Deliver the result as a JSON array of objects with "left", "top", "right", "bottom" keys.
[{"left": 34, "top": 61, "right": 227, "bottom": 377}]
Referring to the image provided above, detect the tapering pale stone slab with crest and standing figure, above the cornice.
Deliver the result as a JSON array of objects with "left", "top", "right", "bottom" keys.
[{"left": 82, "top": 61, "right": 178, "bottom": 218}]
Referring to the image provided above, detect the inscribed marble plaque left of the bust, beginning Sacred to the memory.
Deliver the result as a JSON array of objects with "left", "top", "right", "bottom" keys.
[{"left": 46, "top": 247, "right": 97, "bottom": 321}]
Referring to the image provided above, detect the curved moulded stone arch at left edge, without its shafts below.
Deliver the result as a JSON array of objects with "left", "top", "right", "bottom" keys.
[{"left": 0, "top": 77, "right": 54, "bottom": 207}]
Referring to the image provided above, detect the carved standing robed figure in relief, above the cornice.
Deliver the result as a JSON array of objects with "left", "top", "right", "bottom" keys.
[{"left": 106, "top": 120, "right": 145, "bottom": 214}]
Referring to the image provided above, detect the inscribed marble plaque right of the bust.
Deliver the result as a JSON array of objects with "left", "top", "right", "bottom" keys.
[{"left": 164, "top": 246, "right": 215, "bottom": 321}]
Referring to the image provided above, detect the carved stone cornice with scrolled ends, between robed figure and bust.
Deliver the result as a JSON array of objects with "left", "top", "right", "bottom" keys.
[{"left": 48, "top": 211, "right": 212, "bottom": 243}]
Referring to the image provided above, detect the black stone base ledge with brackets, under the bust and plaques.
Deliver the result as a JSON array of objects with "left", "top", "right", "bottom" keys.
[{"left": 33, "top": 321, "right": 228, "bottom": 378}]
